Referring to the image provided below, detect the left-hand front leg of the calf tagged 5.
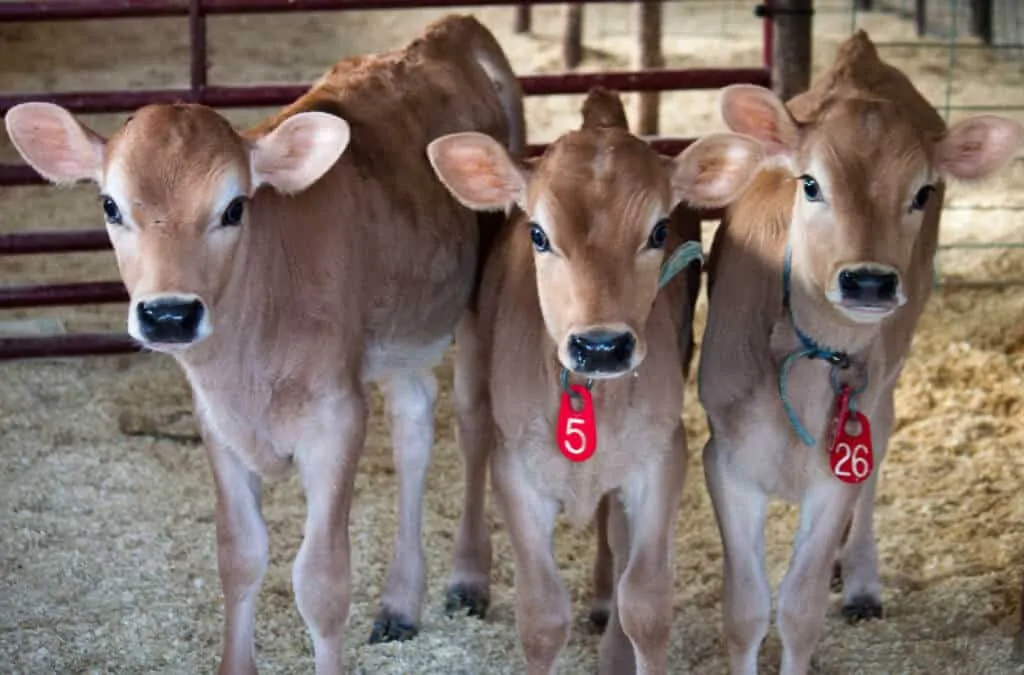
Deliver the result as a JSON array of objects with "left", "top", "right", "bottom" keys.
[{"left": 492, "top": 449, "right": 572, "bottom": 675}]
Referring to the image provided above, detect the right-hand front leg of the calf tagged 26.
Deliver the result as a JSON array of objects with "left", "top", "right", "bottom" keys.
[{"left": 778, "top": 474, "right": 860, "bottom": 675}]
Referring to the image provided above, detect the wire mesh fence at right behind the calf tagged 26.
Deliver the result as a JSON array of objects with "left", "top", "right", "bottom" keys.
[{"left": 848, "top": 0, "right": 1024, "bottom": 285}]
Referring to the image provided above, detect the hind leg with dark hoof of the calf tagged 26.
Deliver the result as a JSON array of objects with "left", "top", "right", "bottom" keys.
[{"left": 841, "top": 394, "right": 894, "bottom": 622}]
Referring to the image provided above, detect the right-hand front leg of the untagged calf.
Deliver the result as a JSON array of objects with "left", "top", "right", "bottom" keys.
[{"left": 292, "top": 384, "right": 367, "bottom": 675}]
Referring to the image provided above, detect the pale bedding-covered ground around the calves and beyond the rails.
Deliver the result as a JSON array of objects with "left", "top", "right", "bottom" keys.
[{"left": 0, "top": 2, "right": 1024, "bottom": 674}]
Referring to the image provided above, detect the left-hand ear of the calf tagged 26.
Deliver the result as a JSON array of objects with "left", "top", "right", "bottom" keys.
[{"left": 720, "top": 84, "right": 800, "bottom": 157}]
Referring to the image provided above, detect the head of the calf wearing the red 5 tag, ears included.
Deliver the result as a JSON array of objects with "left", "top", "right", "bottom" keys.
[{"left": 428, "top": 89, "right": 764, "bottom": 378}]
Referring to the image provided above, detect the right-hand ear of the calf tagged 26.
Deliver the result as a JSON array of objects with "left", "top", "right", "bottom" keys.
[{"left": 938, "top": 115, "right": 1024, "bottom": 180}]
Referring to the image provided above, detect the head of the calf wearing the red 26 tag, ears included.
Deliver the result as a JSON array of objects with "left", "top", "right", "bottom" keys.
[{"left": 722, "top": 31, "right": 1024, "bottom": 325}]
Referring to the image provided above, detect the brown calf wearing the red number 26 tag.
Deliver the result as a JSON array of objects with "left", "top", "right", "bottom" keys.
[{"left": 699, "top": 27, "right": 1024, "bottom": 675}]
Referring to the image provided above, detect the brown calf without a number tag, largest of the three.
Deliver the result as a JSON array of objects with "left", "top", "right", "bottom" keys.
[{"left": 7, "top": 16, "right": 523, "bottom": 673}]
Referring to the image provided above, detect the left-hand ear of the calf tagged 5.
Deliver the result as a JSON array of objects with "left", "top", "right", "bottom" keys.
[{"left": 427, "top": 131, "right": 526, "bottom": 211}]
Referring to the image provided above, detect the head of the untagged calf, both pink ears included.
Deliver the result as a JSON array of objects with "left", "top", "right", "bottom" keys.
[{"left": 6, "top": 102, "right": 349, "bottom": 351}]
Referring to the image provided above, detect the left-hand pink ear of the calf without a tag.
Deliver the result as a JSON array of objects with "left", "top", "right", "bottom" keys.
[{"left": 4, "top": 102, "right": 105, "bottom": 185}]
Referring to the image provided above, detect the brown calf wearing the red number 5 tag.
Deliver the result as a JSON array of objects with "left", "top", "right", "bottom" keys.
[{"left": 421, "top": 90, "right": 763, "bottom": 674}]
